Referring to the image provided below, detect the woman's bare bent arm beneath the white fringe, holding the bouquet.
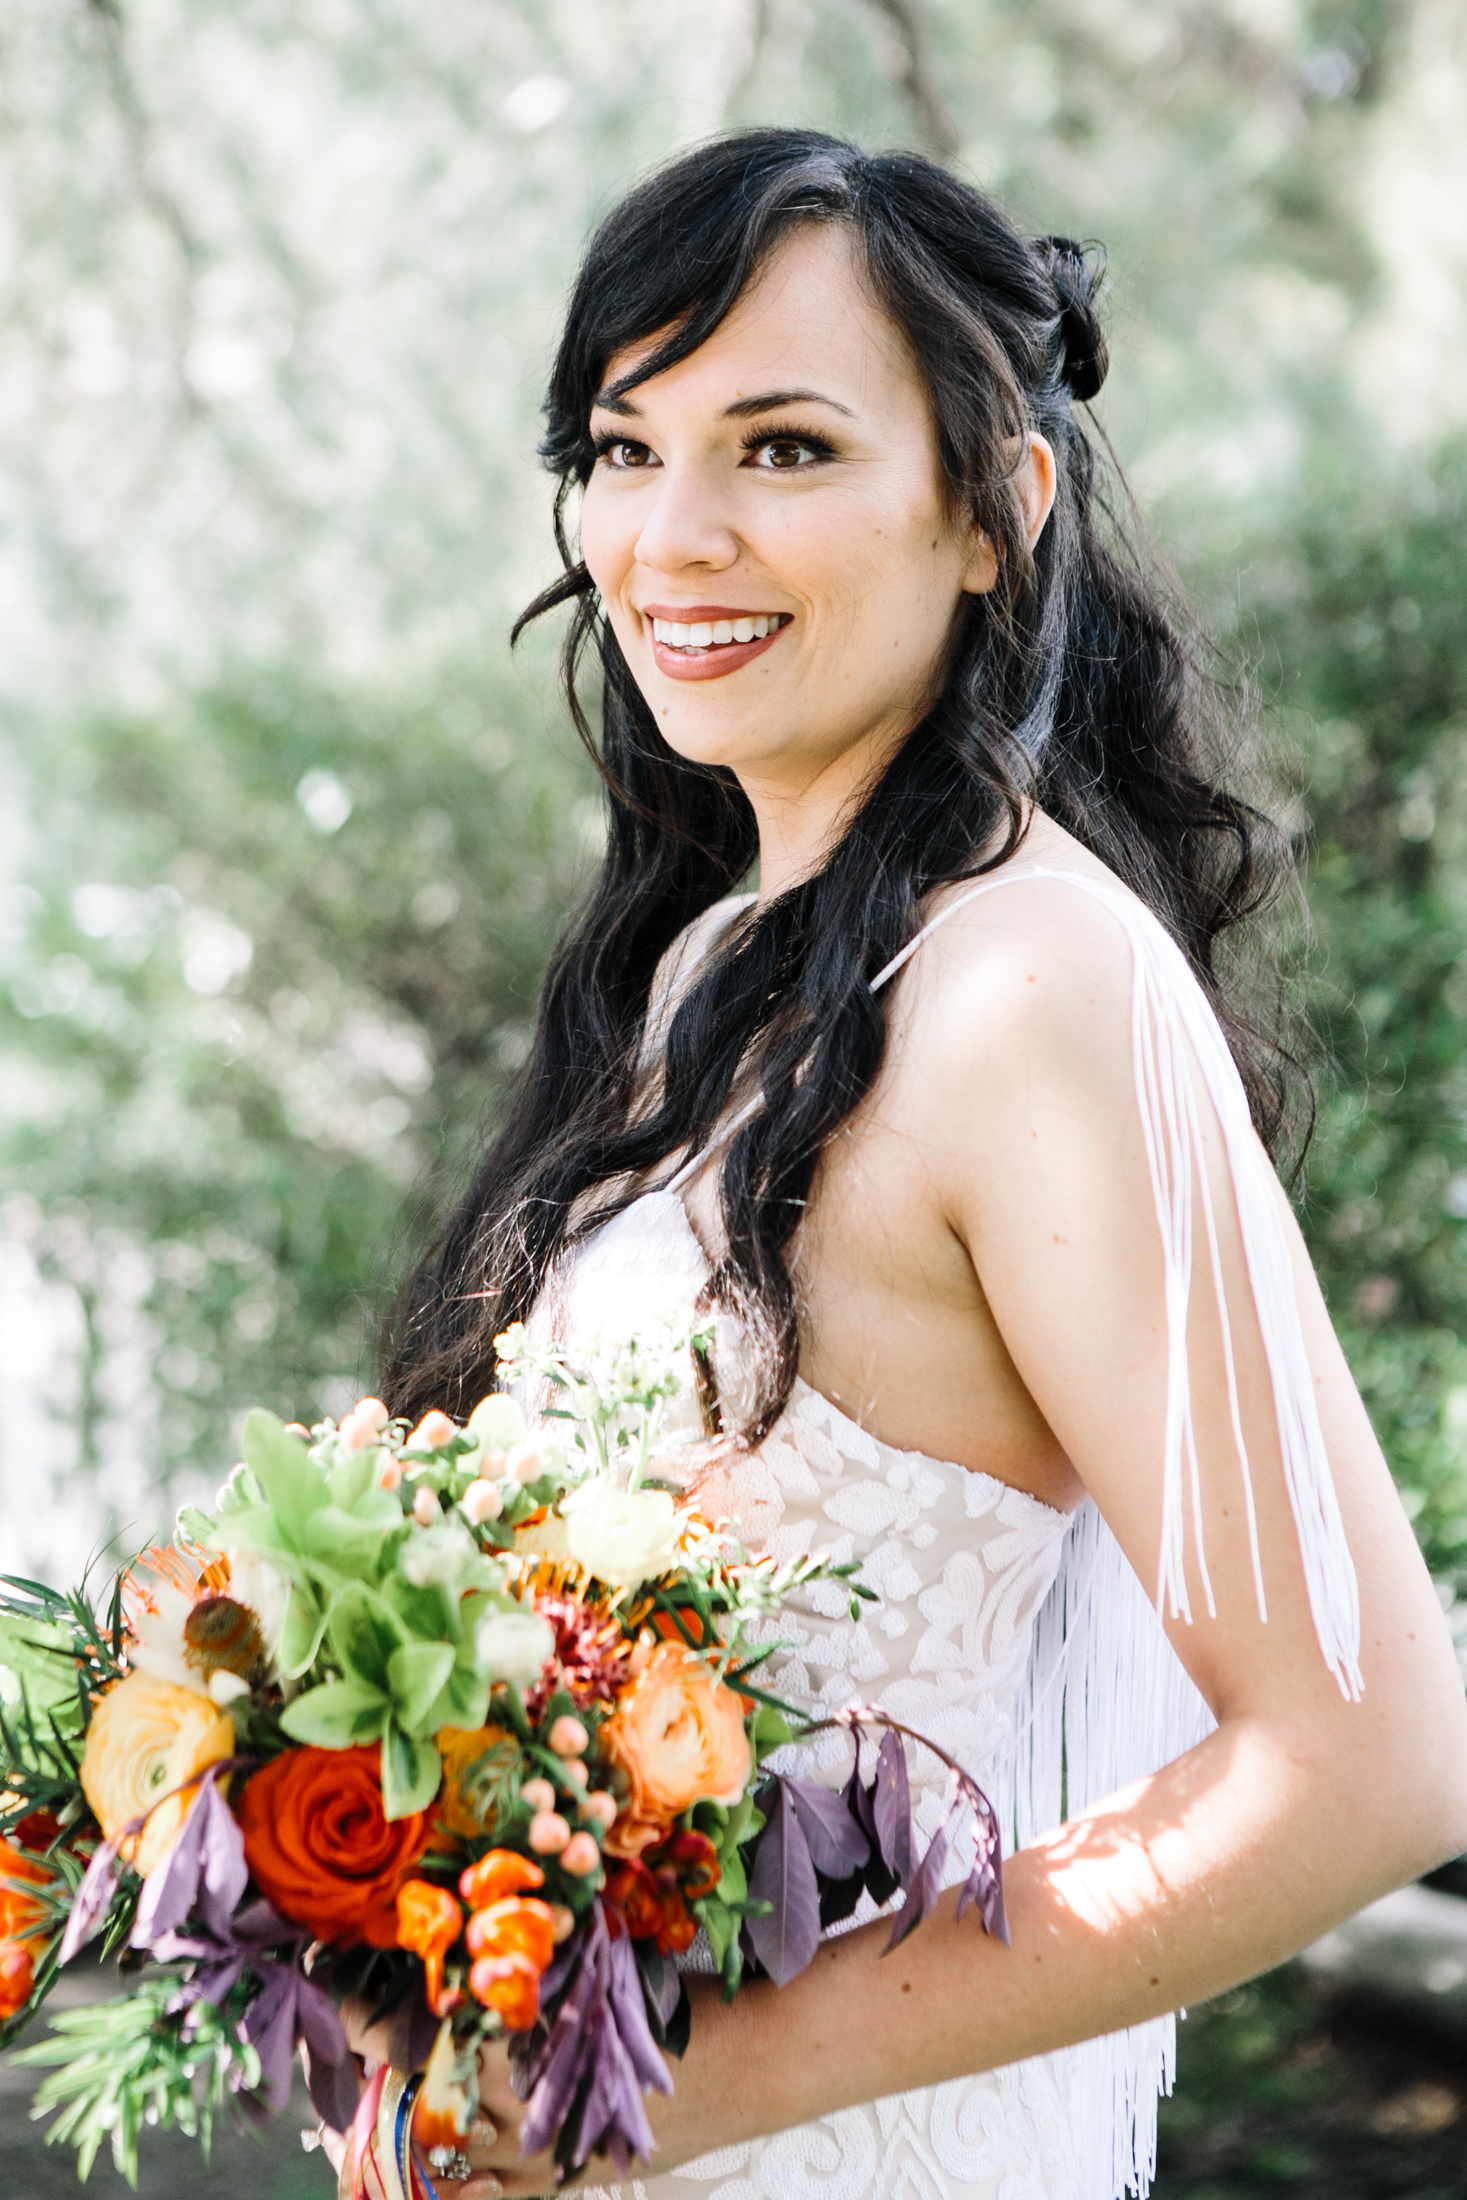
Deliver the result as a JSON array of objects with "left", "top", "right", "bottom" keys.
[{"left": 455, "top": 889, "right": 1467, "bottom": 2193}]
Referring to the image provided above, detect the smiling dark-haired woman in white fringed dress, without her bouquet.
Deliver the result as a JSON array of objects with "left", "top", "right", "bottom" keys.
[{"left": 387, "top": 130, "right": 1467, "bottom": 2200}]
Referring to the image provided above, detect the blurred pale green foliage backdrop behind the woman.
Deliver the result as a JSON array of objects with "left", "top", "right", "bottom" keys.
[{"left": 0, "top": 0, "right": 1467, "bottom": 1619}]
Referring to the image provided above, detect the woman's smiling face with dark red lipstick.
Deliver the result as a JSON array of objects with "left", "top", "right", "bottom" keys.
[{"left": 581, "top": 227, "right": 1049, "bottom": 818}]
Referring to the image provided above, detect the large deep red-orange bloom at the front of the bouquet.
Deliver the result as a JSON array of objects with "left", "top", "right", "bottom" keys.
[{"left": 240, "top": 1742, "right": 429, "bottom": 1947}]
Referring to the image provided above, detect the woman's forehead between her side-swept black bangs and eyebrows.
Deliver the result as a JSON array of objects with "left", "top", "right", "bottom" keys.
[{"left": 603, "top": 222, "right": 926, "bottom": 416}]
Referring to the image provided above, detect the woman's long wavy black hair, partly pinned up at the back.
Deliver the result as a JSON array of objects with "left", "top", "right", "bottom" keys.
[{"left": 385, "top": 130, "right": 1287, "bottom": 1441}]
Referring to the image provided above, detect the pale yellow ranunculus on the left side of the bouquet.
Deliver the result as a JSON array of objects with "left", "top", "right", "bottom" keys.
[{"left": 81, "top": 1672, "right": 235, "bottom": 1877}]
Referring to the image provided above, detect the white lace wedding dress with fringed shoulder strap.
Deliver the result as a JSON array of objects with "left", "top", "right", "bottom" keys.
[{"left": 532, "top": 869, "right": 1359, "bottom": 2200}]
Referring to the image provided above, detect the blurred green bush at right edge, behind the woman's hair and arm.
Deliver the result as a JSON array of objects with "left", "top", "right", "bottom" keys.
[{"left": 1258, "top": 444, "right": 1467, "bottom": 1586}]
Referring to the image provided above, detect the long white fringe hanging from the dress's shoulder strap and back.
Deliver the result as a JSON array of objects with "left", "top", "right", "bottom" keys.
[{"left": 873, "top": 869, "right": 1364, "bottom": 2200}]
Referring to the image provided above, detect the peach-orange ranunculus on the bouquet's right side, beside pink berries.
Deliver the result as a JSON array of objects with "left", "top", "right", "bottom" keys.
[{"left": 600, "top": 1643, "right": 754, "bottom": 1857}]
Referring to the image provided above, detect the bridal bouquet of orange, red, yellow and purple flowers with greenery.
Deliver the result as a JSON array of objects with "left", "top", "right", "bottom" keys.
[{"left": 0, "top": 1324, "right": 1005, "bottom": 2200}]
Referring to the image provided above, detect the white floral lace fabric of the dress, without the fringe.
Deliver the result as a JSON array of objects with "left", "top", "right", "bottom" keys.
[{"left": 537, "top": 1195, "right": 1080, "bottom": 2200}]
